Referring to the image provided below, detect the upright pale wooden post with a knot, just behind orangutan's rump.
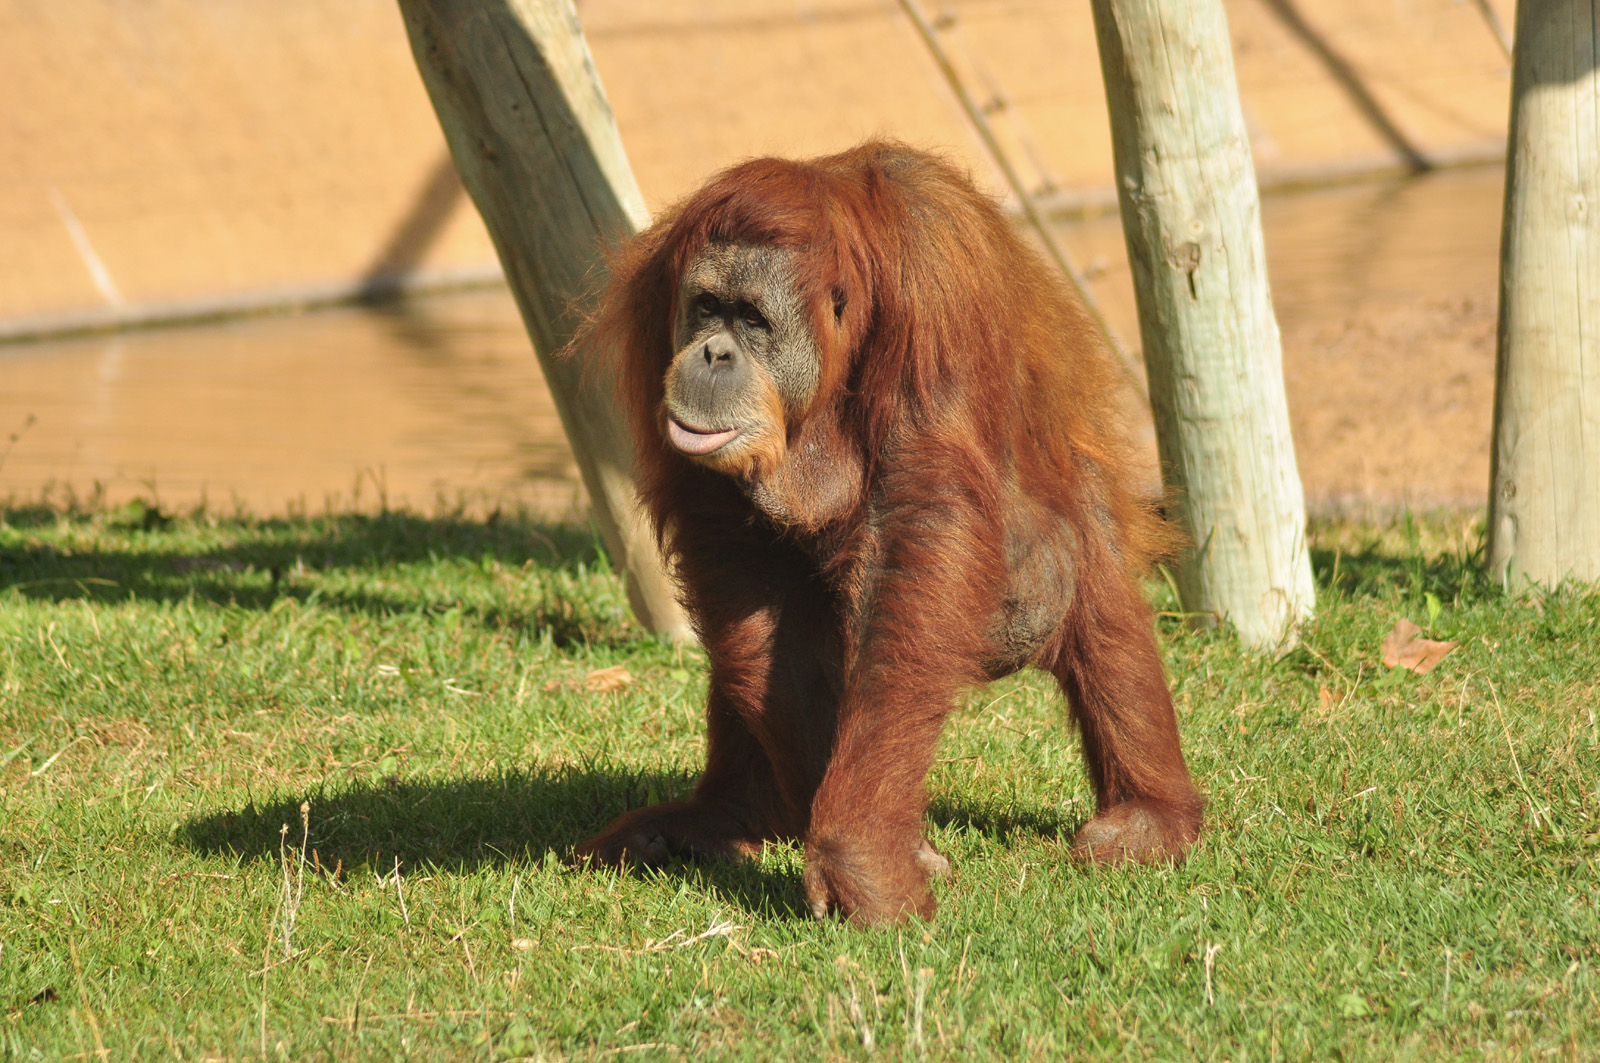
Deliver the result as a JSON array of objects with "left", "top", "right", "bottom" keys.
[{"left": 1093, "top": 0, "right": 1315, "bottom": 650}]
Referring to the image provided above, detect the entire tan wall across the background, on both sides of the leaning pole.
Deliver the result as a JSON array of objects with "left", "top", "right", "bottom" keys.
[{"left": 0, "top": 0, "right": 1512, "bottom": 336}]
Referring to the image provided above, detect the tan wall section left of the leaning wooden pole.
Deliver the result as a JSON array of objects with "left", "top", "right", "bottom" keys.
[{"left": 0, "top": 0, "right": 490, "bottom": 336}]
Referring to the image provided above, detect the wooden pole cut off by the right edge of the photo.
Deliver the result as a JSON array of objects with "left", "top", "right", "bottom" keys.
[{"left": 1488, "top": 0, "right": 1600, "bottom": 589}]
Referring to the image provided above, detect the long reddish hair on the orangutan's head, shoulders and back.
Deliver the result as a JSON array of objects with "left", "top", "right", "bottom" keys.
[{"left": 586, "top": 141, "right": 1171, "bottom": 570}]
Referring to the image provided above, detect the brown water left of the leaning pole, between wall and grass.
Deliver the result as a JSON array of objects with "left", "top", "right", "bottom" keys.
[{"left": 0, "top": 291, "right": 579, "bottom": 512}]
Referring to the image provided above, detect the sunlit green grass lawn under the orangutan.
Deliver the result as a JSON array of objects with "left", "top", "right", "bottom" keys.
[{"left": 0, "top": 506, "right": 1600, "bottom": 1063}]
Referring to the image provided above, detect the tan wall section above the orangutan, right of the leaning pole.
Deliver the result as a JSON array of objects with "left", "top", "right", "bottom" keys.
[{"left": 579, "top": 0, "right": 1512, "bottom": 209}]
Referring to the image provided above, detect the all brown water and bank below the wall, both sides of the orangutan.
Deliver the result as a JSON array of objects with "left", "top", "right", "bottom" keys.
[{"left": 0, "top": 170, "right": 1501, "bottom": 514}]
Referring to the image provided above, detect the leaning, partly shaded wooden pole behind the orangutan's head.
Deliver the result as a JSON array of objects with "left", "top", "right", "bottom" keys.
[{"left": 400, "top": 0, "right": 691, "bottom": 639}]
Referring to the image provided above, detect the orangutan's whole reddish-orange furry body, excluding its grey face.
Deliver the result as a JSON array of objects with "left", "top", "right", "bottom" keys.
[{"left": 581, "top": 142, "right": 1200, "bottom": 922}]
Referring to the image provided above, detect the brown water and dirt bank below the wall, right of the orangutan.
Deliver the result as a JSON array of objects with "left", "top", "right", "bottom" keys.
[{"left": 1061, "top": 166, "right": 1502, "bottom": 512}]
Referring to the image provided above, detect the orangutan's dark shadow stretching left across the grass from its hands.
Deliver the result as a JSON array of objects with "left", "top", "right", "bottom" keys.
[{"left": 176, "top": 768, "right": 808, "bottom": 919}]
